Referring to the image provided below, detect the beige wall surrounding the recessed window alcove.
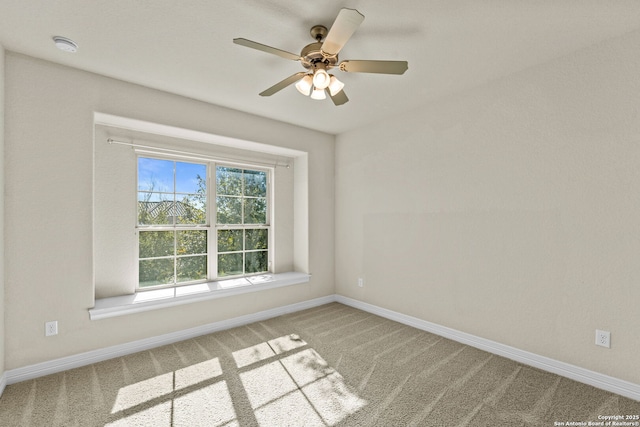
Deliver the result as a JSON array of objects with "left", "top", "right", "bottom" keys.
[{"left": 5, "top": 53, "right": 335, "bottom": 369}]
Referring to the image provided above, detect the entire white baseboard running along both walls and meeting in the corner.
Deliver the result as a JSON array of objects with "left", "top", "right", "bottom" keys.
[{"left": 0, "top": 295, "right": 640, "bottom": 401}]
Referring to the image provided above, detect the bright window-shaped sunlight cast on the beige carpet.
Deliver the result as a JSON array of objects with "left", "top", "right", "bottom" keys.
[{"left": 106, "top": 334, "right": 367, "bottom": 427}]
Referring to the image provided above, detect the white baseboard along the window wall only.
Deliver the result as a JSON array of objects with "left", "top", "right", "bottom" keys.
[{"left": 0, "top": 295, "right": 335, "bottom": 386}]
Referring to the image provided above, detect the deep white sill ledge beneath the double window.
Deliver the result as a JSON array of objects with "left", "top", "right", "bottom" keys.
[{"left": 89, "top": 272, "right": 311, "bottom": 320}]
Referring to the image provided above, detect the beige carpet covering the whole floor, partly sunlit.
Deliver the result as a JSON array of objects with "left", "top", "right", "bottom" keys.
[{"left": 0, "top": 303, "right": 640, "bottom": 427}]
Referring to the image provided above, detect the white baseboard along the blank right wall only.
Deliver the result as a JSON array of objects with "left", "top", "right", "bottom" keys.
[{"left": 335, "top": 295, "right": 640, "bottom": 401}]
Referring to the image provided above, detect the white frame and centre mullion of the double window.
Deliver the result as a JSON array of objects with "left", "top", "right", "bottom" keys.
[{"left": 134, "top": 150, "right": 275, "bottom": 292}]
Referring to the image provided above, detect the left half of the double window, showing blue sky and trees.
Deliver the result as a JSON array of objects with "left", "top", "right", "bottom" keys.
[{"left": 138, "top": 157, "right": 208, "bottom": 287}]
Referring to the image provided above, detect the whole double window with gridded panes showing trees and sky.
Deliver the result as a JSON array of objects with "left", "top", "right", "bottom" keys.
[{"left": 137, "top": 157, "right": 270, "bottom": 289}]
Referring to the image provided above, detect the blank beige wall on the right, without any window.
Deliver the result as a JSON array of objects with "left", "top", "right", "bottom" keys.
[{"left": 336, "top": 32, "right": 640, "bottom": 383}]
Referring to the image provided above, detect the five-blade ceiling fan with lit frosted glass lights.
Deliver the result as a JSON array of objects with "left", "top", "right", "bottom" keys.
[{"left": 233, "top": 8, "right": 408, "bottom": 105}]
